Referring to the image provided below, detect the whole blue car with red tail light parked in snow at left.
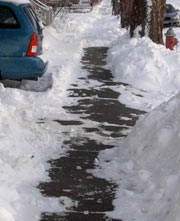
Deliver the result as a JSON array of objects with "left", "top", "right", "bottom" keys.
[{"left": 0, "top": 0, "right": 48, "bottom": 80}]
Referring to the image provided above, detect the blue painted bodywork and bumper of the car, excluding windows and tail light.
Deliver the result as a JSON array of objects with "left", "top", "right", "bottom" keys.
[{"left": 0, "top": 0, "right": 47, "bottom": 80}]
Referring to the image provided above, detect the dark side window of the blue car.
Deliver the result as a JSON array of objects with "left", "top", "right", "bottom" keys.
[{"left": 0, "top": 6, "right": 20, "bottom": 28}]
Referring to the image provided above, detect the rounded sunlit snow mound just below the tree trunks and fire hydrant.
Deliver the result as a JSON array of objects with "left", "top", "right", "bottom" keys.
[{"left": 110, "top": 35, "right": 180, "bottom": 92}]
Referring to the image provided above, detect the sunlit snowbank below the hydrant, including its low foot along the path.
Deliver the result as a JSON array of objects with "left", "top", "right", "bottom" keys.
[{"left": 108, "top": 33, "right": 180, "bottom": 110}]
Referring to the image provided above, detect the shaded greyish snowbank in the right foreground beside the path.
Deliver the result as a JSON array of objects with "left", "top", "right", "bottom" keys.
[{"left": 93, "top": 94, "right": 180, "bottom": 221}]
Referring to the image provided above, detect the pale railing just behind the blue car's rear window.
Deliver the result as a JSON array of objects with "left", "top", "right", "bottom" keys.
[{"left": 30, "top": 0, "right": 53, "bottom": 25}]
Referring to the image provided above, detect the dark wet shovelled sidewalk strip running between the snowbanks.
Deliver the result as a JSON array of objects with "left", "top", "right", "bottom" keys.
[{"left": 39, "top": 47, "right": 145, "bottom": 221}]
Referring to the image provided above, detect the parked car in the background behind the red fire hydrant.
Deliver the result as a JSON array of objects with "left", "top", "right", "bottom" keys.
[{"left": 163, "top": 4, "right": 180, "bottom": 27}]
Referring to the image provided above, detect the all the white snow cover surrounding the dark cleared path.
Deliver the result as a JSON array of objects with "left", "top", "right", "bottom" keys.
[{"left": 0, "top": 0, "right": 180, "bottom": 221}]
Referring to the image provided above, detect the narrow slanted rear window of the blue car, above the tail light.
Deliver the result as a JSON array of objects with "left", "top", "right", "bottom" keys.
[{"left": 24, "top": 6, "right": 41, "bottom": 33}]
